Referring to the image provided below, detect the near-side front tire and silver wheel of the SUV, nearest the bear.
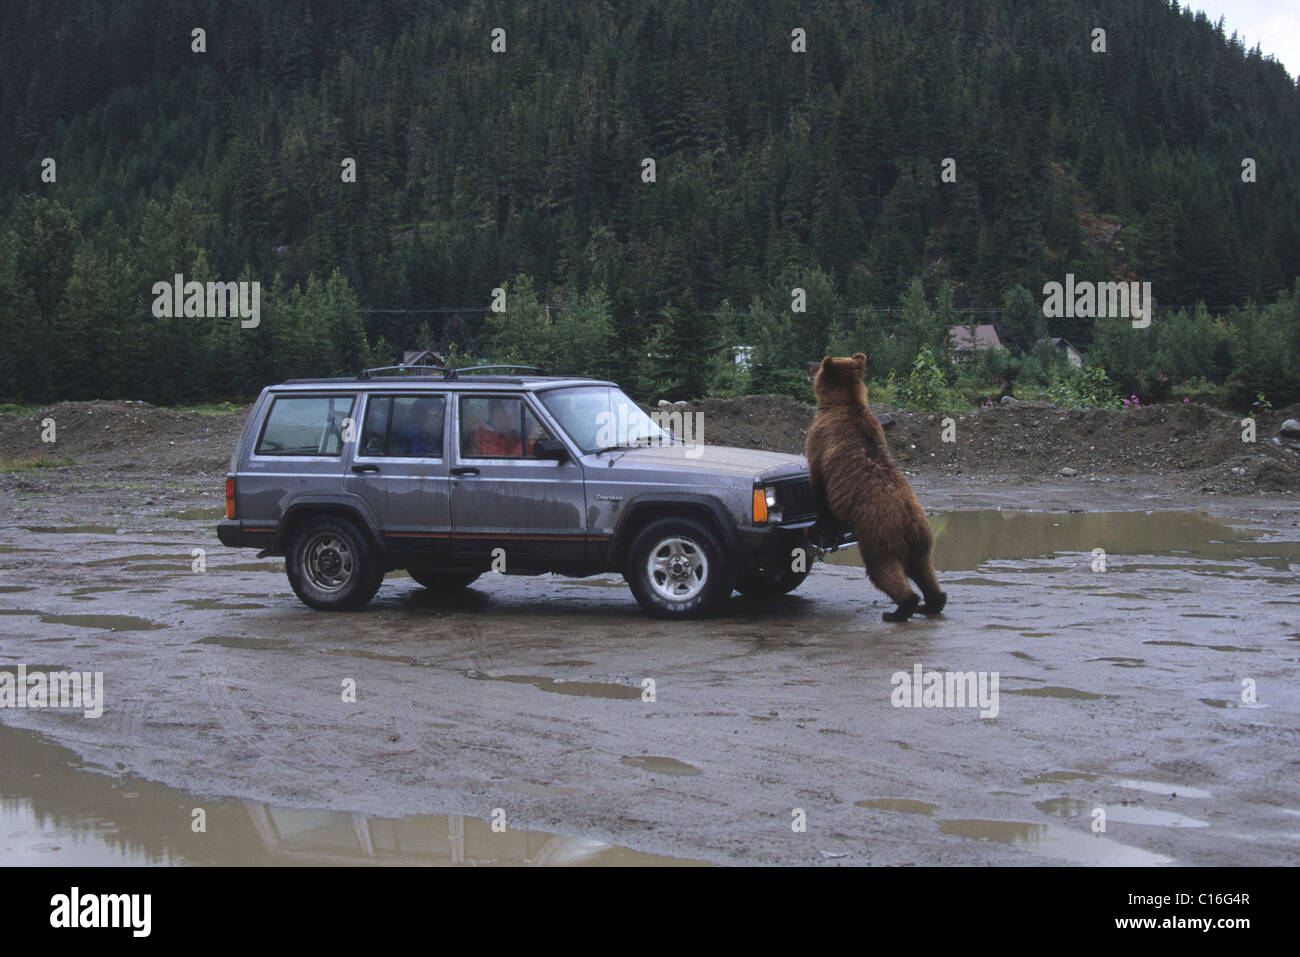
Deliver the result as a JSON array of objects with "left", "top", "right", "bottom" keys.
[{"left": 623, "top": 519, "right": 736, "bottom": 619}]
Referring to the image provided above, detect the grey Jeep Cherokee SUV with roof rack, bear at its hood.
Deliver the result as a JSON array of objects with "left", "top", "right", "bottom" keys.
[{"left": 217, "top": 365, "right": 850, "bottom": 618}]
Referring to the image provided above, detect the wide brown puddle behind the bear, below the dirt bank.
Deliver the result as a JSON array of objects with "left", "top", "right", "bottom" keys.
[{"left": 827, "top": 510, "right": 1300, "bottom": 566}]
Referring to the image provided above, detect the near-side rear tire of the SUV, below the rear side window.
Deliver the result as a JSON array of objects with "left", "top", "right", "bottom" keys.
[{"left": 285, "top": 515, "right": 384, "bottom": 611}]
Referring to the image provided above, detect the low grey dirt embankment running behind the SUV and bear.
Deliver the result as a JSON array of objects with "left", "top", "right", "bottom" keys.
[{"left": 0, "top": 395, "right": 1300, "bottom": 494}]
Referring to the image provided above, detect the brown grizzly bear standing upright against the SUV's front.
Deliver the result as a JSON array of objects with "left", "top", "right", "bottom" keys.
[{"left": 805, "top": 352, "right": 948, "bottom": 622}]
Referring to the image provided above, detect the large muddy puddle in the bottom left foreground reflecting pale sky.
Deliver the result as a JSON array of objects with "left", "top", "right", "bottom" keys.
[{"left": 0, "top": 726, "right": 702, "bottom": 867}]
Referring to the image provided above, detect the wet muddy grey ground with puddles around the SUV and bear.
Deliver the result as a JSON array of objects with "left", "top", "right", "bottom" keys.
[{"left": 0, "top": 399, "right": 1300, "bottom": 865}]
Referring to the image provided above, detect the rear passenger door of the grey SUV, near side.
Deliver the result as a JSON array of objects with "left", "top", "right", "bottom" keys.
[{"left": 345, "top": 390, "right": 451, "bottom": 567}]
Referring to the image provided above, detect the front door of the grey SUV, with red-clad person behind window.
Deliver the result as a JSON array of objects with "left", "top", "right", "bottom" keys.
[{"left": 450, "top": 393, "right": 586, "bottom": 571}]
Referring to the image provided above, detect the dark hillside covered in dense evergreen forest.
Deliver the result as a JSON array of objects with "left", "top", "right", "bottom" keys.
[{"left": 0, "top": 0, "right": 1300, "bottom": 402}]
